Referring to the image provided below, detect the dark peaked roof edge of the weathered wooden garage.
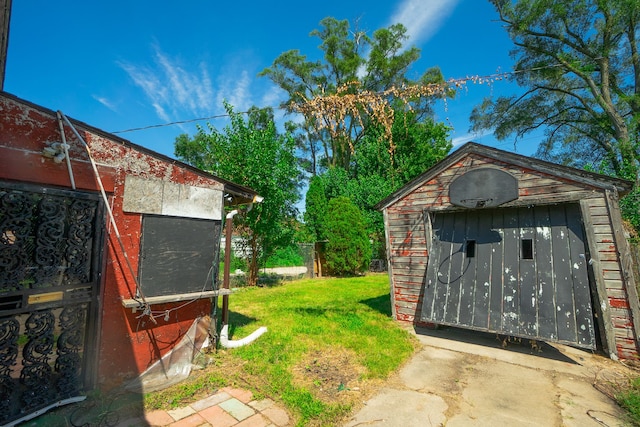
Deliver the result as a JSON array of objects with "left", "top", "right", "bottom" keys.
[{"left": 375, "top": 142, "right": 633, "bottom": 210}]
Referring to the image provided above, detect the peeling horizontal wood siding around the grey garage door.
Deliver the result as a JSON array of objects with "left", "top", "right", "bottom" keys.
[{"left": 384, "top": 153, "right": 637, "bottom": 358}]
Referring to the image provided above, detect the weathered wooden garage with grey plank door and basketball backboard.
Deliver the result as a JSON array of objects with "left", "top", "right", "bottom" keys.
[{"left": 377, "top": 143, "right": 640, "bottom": 359}]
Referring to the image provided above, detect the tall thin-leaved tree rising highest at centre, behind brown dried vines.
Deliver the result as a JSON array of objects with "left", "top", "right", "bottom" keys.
[{"left": 261, "top": 17, "right": 443, "bottom": 174}]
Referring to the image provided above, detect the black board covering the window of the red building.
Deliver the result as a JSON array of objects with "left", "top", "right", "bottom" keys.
[{"left": 138, "top": 215, "right": 222, "bottom": 297}]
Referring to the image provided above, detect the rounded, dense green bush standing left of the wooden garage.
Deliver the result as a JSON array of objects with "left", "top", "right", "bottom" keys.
[{"left": 324, "top": 197, "right": 371, "bottom": 276}]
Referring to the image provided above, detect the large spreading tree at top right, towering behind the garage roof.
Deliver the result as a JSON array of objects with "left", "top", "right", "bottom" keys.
[{"left": 471, "top": 0, "right": 640, "bottom": 183}]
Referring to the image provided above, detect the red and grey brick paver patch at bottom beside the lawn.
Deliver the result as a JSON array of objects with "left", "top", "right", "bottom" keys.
[{"left": 118, "top": 387, "right": 291, "bottom": 427}]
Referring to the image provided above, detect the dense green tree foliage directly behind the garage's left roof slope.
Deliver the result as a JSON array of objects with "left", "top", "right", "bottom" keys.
[{"left": 304, "top": 110, "right": 452, "bottom": 258}]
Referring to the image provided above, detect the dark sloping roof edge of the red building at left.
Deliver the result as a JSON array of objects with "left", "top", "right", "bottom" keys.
[{"left": 0, "top": 91, "right": 260, "bottom": 204}]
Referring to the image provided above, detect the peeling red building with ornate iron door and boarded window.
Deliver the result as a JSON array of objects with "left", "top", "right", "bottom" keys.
[{"left": 0, "top": 92, "right": 257, "bottom": 425}]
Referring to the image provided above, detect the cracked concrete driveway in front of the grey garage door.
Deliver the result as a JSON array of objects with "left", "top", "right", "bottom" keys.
[{"left": 346, "top": 328, "right": 631, "bottom": 427}]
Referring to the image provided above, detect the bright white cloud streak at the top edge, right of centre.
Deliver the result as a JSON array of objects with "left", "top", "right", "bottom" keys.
[{"left": 390, "top": 0, "right": 459, "bottom": 44}]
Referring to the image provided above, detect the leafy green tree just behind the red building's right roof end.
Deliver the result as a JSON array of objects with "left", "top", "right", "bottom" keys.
[{"left": 175, "top": 103, "right": 300, "bottom": 285}]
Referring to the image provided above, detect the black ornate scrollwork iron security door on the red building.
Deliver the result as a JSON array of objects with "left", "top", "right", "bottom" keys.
[{"left": 0, "top": 181, "right": 104, "bottom": 425}]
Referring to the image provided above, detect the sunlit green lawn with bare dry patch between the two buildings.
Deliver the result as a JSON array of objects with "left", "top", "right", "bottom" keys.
[{"left": 145, "top": 274, "right": 416, "bottom": 425}]
